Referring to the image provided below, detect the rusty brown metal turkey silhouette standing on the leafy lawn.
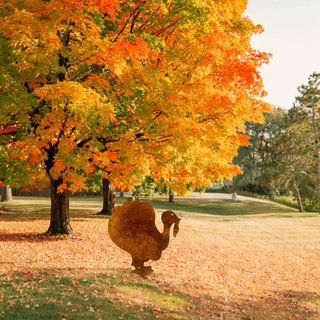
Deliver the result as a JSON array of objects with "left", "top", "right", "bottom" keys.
[{"left": 108, "top": 201, "right": 181, "bottom": 277}]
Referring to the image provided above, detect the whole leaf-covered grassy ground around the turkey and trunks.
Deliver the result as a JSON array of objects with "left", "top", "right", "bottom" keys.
[{"left": 0, "top": 198, "right": 320, "bottom": 320}]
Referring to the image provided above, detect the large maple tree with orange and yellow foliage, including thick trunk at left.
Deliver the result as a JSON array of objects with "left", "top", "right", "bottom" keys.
[{"left": 0, "top": 0, "right": 270, "bottom": 234}]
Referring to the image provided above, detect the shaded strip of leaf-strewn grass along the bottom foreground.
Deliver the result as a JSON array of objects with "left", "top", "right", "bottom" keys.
[{"left": 0, "top": 269, "right": 320, "bottom": 320}]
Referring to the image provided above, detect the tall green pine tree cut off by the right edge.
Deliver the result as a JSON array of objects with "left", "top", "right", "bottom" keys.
[{"left": 272, "top": 73, "right": 320, "bottom": 210}]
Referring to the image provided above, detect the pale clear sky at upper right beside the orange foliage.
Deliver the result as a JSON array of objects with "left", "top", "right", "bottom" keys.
[{"left": 245, "top": 0, "right": 320, "bottom": 109}]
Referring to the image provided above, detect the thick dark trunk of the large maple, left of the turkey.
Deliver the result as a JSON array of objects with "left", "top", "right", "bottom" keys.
[{"left": 46, "top": 178, "right": 72, "bottom": 235}]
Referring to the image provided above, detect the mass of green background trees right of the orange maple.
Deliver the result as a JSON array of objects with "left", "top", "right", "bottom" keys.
[{"left": 235, "top": 73, "right": 320, "bottom": 211}]
